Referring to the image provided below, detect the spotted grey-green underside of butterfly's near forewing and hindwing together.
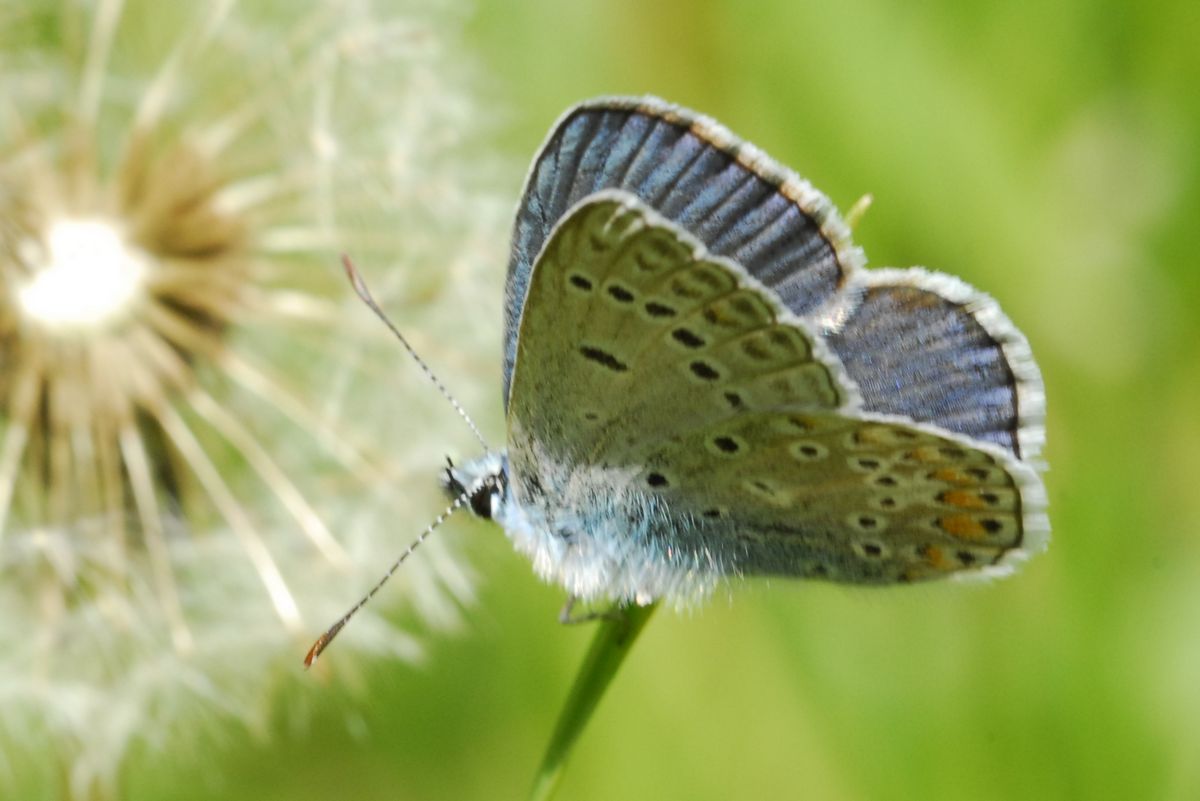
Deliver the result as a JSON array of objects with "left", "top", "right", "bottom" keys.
[{"left": 509, "top": 192, "right": 1044, "bottom": 583}]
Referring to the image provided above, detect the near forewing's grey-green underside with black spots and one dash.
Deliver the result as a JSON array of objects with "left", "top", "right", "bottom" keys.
[{"left": 510, "top": 192, "right": 853, "bottom": 464}]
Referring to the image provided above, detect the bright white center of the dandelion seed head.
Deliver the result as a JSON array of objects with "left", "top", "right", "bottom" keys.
[{"left": 19, "top": 219, "right": 145, "bottom": 327}]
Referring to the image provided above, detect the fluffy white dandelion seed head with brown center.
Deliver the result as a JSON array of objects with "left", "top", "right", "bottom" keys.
[{"left": 0, "top": 0, "right": 505, "bottom": 797}]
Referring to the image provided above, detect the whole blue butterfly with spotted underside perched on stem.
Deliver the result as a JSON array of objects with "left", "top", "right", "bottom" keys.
[{"left": 445, "top": 97, "right": 1049, "bottom": 604}]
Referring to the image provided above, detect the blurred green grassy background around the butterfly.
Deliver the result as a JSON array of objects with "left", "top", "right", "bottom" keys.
[{"left": 125, "top": 0, "right": 1200, "bottom": 801}]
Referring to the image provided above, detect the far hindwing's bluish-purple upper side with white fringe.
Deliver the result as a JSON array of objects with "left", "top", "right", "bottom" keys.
[{"left": 826, "top": 267, "right": 1045, "bottom": 459}]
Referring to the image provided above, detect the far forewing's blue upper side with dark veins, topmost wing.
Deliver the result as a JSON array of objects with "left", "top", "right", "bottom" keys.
[{"left": 504, "top": 97, "right": 863, "bottom": 403}]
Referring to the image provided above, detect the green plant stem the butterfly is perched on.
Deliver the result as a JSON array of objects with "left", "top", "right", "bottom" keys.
[{"left": 529, "top": 603, "right": 659, "bottom": 801}]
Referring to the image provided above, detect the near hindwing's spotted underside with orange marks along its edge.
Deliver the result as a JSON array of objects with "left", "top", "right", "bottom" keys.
[{"left": 638, "top": 411, "right": 1040, "bottom": 584}]
